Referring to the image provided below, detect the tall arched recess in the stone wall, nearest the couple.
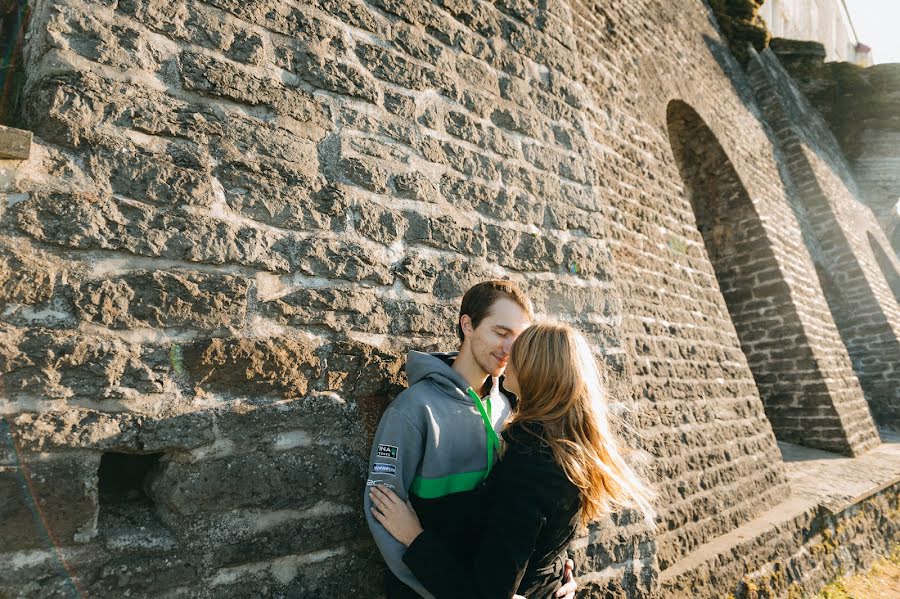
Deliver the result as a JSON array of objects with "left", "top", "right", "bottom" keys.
[{"left": 667, "top": 100, "right": 852, "bottom": 453}]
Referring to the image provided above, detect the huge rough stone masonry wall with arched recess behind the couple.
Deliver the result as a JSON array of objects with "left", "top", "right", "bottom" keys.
[{"left": 0, "top": 0, "right": 900, "bottom": 597}]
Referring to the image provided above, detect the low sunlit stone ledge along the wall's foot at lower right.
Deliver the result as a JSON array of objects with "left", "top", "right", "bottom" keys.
[{"left": 659, "top": 429, "right": 900, "bottom": 598}]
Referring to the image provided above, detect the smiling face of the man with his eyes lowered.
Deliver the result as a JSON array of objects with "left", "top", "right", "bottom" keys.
[{"left": 466, "top": 298, "right": 531, "bottom": 376}]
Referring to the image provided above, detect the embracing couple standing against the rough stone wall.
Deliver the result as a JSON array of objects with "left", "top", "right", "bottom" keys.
[{"left": 365, "top": 281, "right": 654, "bottom": 599}]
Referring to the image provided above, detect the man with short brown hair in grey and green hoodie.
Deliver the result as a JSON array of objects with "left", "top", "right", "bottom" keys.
[{"left": 364, "top": 281, "right": 577, "bottom": 599}]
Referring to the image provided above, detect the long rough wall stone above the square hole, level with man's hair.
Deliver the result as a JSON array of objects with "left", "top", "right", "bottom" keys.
[{"left": 74, "top": 270, "right": 249, "bottom": 329}]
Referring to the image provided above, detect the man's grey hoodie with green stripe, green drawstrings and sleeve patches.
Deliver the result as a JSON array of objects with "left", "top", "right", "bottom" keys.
[{"left": 364, "top": 351, "right": 510, "bottom": 597}]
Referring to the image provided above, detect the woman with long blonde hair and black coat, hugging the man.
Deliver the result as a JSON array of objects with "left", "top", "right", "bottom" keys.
[{"left": 370, "top": 323, "right": 655, "bottom": 599}]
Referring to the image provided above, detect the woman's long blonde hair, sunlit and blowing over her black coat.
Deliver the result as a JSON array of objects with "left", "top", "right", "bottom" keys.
[{"left": 509, "top": 323, "right": 655, "bottom": 525}]
